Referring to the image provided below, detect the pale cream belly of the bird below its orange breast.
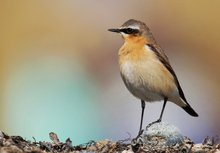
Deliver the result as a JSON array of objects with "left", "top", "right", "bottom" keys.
[{"left": 120, "top": 60, "right": 177, "bottom": 102}]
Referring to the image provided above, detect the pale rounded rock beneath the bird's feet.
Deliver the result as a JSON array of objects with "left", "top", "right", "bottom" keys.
[{"left": 131, "top": 122, "right": 184, "bottom": 152}]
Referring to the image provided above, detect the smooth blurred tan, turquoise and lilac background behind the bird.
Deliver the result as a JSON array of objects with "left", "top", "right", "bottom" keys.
[{"left": 0, "top": 0, "right": 220, "bottom": 144}]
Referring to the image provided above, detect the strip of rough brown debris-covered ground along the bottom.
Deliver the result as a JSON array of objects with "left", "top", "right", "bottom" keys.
[{"left": 0, "top": 131, "right": 220, "bottom": 153}]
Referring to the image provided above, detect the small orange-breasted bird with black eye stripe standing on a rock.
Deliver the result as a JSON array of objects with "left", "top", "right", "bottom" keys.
[{"left": 108, "top": 19, "right": 198, "bottom": 134}]
